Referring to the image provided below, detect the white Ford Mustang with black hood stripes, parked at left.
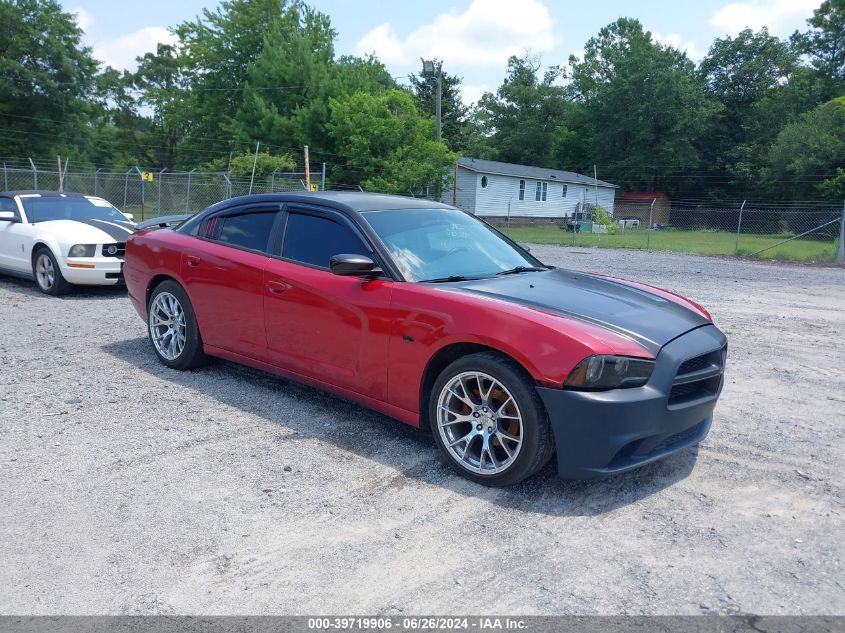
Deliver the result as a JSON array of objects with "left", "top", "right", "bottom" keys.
[{"left": 0, "top": 191, "right": 135, "bottom": 295}]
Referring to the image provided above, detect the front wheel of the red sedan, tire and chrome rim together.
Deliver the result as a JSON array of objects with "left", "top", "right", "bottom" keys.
[{"left": 429, "top": 352, "right": 554, "bottom": 487}]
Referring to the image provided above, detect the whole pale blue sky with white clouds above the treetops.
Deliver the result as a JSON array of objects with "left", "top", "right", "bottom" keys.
[{"left": 62, "top": 0, "right": 821, "bottom": 103}]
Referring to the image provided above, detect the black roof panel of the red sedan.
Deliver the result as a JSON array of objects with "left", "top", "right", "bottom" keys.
[{"left": 206, "top": 191, "right": 453, "bottom": 213}]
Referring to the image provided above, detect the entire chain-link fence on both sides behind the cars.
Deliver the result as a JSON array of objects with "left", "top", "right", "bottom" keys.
[{"left": 0, "top": 164, "right": 845, "bottom": 263}]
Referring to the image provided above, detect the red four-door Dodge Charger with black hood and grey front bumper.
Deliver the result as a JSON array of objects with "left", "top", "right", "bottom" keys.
[{"left": 124, "top": 192, "right": 727, "bottom": 486}]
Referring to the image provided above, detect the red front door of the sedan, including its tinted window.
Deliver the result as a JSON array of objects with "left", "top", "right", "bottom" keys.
[{"left": 264, "top": 207, "right": 395, "bottom": 400}]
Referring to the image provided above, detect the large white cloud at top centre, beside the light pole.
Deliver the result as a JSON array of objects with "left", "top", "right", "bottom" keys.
[{"left": 355, "top": 0, "right": 560, "bottom": 67}]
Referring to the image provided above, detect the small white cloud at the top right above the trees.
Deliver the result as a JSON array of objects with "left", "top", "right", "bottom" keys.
[{"left": 710, "top": 0, "right": 821, "bottom": 36}]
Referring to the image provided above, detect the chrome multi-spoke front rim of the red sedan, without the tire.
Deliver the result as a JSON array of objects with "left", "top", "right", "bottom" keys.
[{"left": 437, "top": 371, "right": 523, "bottom": 475}]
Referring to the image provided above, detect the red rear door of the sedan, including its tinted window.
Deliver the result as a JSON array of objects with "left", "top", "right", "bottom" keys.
[{"left": 181, "top": 204, "right": 281, "bottom": 361}]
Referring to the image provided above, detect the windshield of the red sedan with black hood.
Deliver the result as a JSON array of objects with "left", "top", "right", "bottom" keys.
[{"left": 362, "top": 209, "right": 542, "bottom": 281}]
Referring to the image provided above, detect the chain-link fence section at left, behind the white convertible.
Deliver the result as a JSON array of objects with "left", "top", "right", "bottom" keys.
[{"left": 0, "top": 165, "right": 325, "bottom": 220}]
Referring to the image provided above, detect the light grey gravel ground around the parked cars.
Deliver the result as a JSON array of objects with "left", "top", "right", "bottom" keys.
[{"left": 0, "top": 246, "right": 845, "bottom": 615}]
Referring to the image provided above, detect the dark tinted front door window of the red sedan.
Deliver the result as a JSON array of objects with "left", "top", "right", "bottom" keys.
[{"left": 282, "top": 213, "right": 370, "bottom": 268}]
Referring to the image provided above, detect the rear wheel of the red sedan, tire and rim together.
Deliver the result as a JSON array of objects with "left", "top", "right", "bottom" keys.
[{"left": 147, "top": 279, "right": 208, "bottom": 370}]
